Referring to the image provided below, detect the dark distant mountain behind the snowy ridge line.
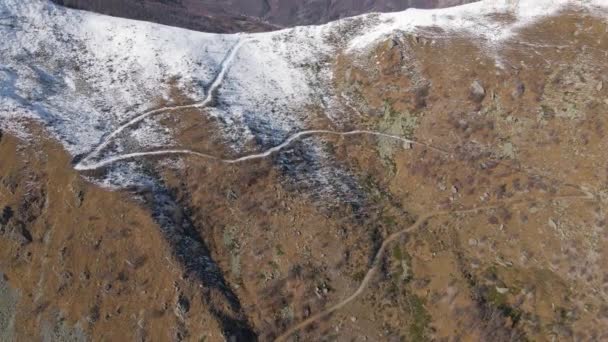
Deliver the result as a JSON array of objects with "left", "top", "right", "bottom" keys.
[{"left": 53, "top": 0, "right": 475, "bottom": 33}]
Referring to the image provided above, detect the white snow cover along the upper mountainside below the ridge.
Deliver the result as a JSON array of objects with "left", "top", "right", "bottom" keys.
[{"left": 0, "top": 0, "right": 608, "bottom": 187}]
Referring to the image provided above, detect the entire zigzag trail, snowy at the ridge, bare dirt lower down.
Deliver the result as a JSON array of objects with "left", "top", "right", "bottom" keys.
[{"left": 74, "top": 28, "right": 595, "bottom": 341}]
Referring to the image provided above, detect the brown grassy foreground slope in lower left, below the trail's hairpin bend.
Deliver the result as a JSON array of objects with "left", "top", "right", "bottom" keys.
[{"left": 0, "top": 127, "right": 236, "bottom": 341}]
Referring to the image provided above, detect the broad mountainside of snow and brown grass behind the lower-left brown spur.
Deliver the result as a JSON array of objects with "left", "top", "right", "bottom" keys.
[{"left": 0, "top": 0, "right": 608, "bottom": 341}]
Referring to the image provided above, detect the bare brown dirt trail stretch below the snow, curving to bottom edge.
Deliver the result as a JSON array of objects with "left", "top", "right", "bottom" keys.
[{"left": 275, "top": 194, "right": 594, "bottom": 342}]
